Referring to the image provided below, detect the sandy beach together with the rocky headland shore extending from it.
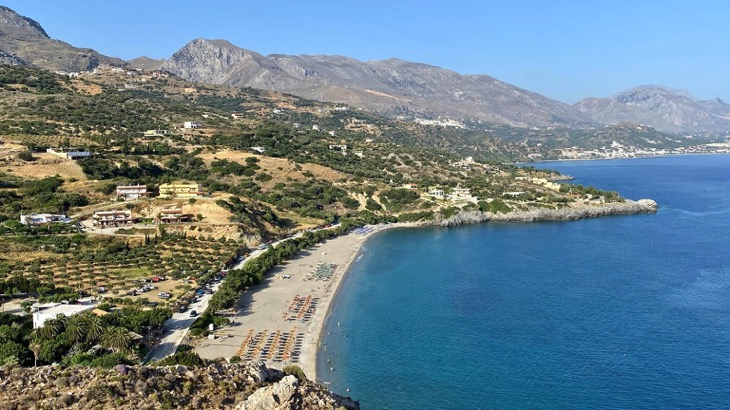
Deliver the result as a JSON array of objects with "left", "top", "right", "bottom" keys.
[{"left": 195, "top": 200, "right": 656, "bottom": 381}]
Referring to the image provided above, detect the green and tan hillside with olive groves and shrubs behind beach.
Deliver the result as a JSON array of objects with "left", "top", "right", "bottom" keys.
[{"left": 0, "top": 67, "right": 640, "bottom": 372}]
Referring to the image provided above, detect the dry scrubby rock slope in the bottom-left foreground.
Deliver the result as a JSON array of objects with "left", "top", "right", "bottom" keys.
[{"left": 0, "top": 363, "right": 359, "bottom": 410}]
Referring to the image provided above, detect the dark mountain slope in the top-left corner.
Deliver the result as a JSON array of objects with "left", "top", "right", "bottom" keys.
[{"left": 0, "top": 6, "right": 126, "bottom": 71}]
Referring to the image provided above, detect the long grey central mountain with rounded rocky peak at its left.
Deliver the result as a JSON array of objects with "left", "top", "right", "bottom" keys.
[{"left": 162, "top": 39, "right": 591, "bottom": 126}]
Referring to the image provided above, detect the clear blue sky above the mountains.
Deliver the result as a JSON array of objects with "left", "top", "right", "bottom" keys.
[{"left": 0, "top": 0, "right": 730, "bottom": 103}]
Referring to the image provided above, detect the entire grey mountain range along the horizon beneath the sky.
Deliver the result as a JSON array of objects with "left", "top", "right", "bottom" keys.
[{"left": 0, "top": 6, "right": 730, "bottom": 134}]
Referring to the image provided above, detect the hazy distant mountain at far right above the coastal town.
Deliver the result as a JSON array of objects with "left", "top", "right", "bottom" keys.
[{"left": 574, "top": 85, "right": 730, "bottom": 133}]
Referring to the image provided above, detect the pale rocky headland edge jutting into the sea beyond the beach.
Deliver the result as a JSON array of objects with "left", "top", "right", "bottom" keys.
[{"left": 426, "top": 199, "right": 657, "bottom": 226}]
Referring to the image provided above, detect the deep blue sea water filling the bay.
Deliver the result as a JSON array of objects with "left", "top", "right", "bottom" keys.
[{"left": 318, "top": 155, "right": 730, "bottom": 409}]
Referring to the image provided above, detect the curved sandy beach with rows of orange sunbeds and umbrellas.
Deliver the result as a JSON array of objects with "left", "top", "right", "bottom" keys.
[{"left": 195, "top": 224, "right": 410, "bottom": 380}]
